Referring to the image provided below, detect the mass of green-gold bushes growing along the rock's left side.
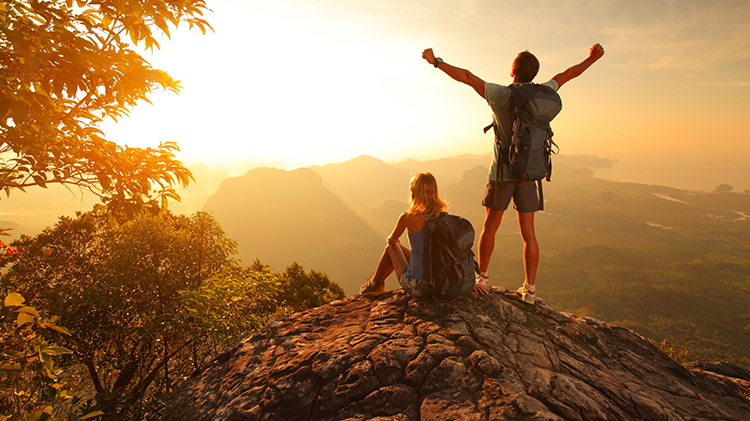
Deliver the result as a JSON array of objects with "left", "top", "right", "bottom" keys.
[{"left": 0, "top": 205, "right": 344, "bottom": 419}]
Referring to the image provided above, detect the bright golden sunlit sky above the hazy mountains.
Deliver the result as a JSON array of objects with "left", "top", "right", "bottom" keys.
[{"left": 104, "top": 0, "right": 750, "bottom": 180}]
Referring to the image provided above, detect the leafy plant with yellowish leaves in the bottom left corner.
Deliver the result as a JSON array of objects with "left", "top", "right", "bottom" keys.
[{"left": 0, "top": 293, "right": 102, "bottom": 420}]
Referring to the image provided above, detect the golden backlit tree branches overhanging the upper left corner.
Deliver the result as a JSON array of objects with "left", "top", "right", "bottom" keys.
[{"left": 0, "top": 0, "right": 210, "bottom": 212}]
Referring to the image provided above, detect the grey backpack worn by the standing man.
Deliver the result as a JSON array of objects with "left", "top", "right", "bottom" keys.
[{"left": 484, "top": 83, "right": 562, "bottom": 210}]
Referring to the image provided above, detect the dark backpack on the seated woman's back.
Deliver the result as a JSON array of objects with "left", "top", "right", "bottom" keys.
[{"left": 429, "top": 213, "right": 479, "bottom": 300}]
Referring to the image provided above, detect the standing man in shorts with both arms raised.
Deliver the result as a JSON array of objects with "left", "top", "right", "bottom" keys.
[{"left": 422, "top": 44, "right": 604, "bottom": 304}]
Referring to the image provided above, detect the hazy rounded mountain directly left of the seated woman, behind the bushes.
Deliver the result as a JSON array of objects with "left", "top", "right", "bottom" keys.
[{"left": 205, "top": 168, "right": 384, "bottom": 293}]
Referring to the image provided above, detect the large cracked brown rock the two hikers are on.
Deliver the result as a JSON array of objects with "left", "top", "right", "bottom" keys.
[{"left": 160, "top": 287, "right": 750, "bottom": 421}]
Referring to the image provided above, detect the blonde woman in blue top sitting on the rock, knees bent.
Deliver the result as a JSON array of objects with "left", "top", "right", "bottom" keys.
[{"left": 359, "top": 172, "right": 474, "bottom": 297}]
